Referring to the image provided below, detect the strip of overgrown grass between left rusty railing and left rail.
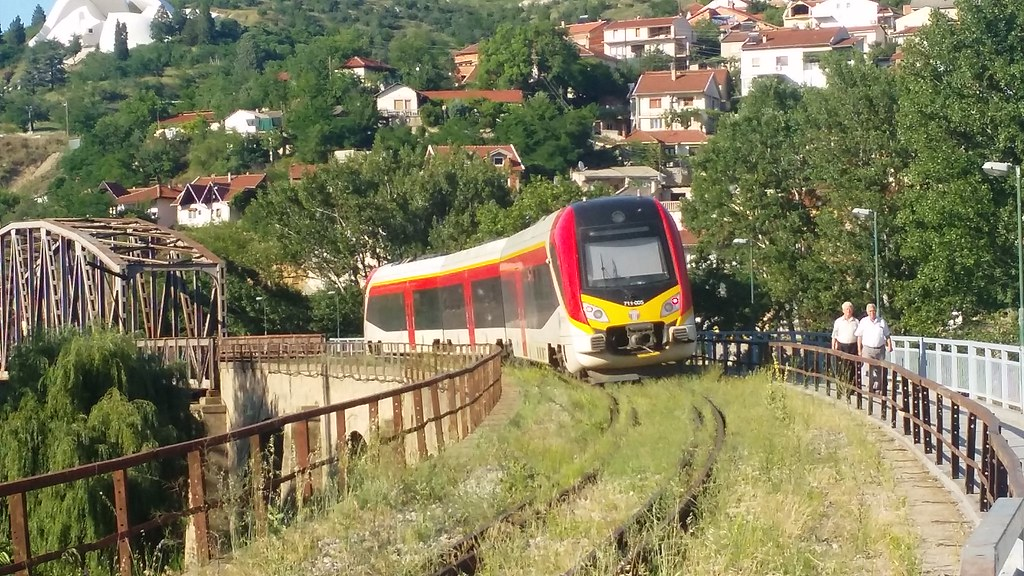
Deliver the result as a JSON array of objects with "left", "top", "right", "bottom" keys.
[{"left": 197, "top": 369, "right": 609, "bottom": 575}]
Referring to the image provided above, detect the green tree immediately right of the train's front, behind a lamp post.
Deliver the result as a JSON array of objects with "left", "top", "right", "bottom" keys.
[{"left": 683, "top": 78, "right": 813, "bottom": 321}]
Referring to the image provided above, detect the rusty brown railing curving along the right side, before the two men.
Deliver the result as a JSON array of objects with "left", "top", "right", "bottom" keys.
[{"left": 696, "top": 338, "right": 1024, "bottom": 511}]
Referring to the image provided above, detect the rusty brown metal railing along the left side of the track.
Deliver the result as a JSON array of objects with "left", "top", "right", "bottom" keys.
[{"left": 0, "top": 339, "right": 502, "bottom": 576}]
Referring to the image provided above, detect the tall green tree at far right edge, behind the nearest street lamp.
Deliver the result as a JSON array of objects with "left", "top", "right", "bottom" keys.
[{"left": 896, "top": 0, "right": 1024, "bottom": 332}]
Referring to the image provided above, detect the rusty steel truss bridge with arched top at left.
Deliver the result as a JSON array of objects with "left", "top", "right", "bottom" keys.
[{"left": 0, "top": 218, "right": 225, "bottom": 387}]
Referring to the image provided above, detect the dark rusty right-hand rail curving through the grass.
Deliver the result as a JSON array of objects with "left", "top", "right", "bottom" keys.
[{"left": 562, "top": 397, "right": 725, "bottom": 576}]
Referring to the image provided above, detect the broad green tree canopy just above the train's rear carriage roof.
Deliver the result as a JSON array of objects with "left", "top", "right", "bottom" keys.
[{"left": 247, "top": 148, "right": 511, "bottom": 286}]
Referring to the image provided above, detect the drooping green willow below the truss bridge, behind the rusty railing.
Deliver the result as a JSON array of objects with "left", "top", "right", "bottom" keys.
[{"left": 0, "top": 331, "right": 202, "bottom": 573}]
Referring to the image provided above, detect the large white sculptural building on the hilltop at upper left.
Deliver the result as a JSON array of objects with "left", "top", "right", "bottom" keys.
[{"left": 29, "top": 0, "right": 174, "bottom": 52}]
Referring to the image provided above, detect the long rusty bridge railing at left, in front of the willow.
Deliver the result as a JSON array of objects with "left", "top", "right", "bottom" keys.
[{"left": 0, "top": 339, "right": 502, "bottom": 576}]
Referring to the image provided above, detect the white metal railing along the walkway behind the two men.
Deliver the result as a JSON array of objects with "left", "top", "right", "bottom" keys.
[{"left": 701, "top": 331, "right": 1024, "bottom": 411}]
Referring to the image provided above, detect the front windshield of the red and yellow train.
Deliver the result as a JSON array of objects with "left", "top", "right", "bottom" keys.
[{"left": 583, "top": 227, "right": 672, "bottom": 288}]
